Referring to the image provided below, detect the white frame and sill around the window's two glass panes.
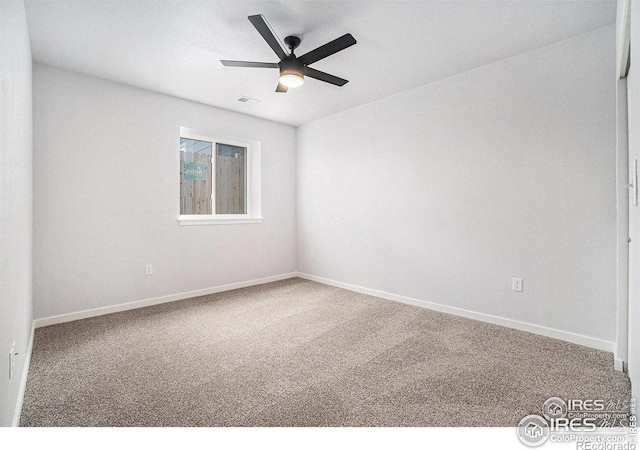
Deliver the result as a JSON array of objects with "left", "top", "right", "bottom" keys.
[{"left": 178, "top": 127, "right": 262, "bottom": 225}]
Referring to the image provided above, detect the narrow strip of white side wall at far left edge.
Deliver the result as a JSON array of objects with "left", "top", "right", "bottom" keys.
[{"left": 0, "top": 1, "right": 33, "bottom": 426}]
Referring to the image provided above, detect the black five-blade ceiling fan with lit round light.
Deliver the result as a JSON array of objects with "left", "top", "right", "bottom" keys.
[{"left": 220, "top": 14, "right": 356, "bottom": 92}]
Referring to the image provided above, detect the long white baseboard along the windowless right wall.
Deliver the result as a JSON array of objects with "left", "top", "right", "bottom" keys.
[{"left": 297, "top": 272, "right": 615, "bottom": 352}]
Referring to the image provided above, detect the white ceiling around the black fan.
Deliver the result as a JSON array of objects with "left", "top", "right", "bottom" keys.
[{"left": 26, "top": 0, "right": 616, "bottom": 125}]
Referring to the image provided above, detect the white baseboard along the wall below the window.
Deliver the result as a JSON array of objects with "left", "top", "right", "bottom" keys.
[{"left": 34, "top": 272, "right": 297, "bottom": 328}]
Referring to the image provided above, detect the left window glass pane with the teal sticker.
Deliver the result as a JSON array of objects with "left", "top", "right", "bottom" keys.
[{"left": 180, "top": 138, "right": 213, "bottom": 215}]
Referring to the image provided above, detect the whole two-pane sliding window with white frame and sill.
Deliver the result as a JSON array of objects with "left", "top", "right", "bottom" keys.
[{"left": 178, "top": 128, "right": 262, "bottom": 225}]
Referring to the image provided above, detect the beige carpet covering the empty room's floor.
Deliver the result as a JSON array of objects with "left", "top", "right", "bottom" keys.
[{"left": 21, "top": 278, "right": 630, "bottom": 426}]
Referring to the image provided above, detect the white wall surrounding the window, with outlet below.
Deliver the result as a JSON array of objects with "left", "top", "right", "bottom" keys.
[{"left": 34, "top": 64, "right": 295, "bottom": 318}]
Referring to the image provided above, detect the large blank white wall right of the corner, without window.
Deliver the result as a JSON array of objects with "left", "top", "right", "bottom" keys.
[{"left": 297, "top": 25, "right": 616, "bottom": 348}]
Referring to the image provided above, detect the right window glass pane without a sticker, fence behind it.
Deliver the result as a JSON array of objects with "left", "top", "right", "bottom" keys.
[{"left": 215, "top": 144, "right": 247, "bottom": 214}]
